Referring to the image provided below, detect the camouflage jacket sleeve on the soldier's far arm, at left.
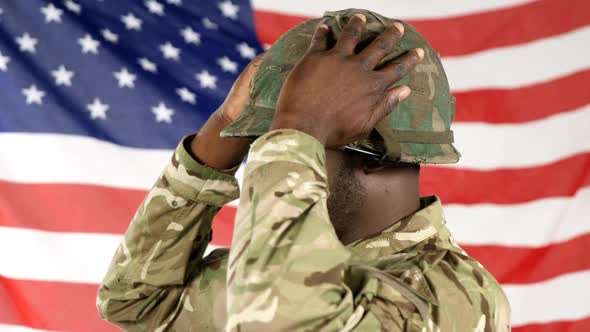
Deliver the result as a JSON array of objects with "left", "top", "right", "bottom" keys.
[{"left": 96, "top": 135, "right": 239, "bottom": 331}]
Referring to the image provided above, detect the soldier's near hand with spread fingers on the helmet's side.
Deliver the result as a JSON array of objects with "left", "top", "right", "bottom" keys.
[{"left": 271, "top": 14, "right": 424, "bottom": 147}]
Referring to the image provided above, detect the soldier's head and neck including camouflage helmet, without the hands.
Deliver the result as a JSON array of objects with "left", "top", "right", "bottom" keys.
[{"left": 222, "top": 9, "right": 459, "bottom": 243}]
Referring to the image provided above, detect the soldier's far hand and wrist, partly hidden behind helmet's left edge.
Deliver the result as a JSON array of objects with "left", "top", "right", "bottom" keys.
[{"left": 191, "top": 53, "right": 264, "bottom": 170}]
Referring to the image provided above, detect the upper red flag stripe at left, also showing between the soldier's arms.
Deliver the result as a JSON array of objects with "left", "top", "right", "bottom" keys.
[{"left": 0, "top": 181, "right": 235, "bottom": 239}]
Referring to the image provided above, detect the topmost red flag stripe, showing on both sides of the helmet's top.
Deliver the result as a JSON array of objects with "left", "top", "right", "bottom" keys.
[{"left": 254, "top": 0, "right": 590, "bottom": 56}]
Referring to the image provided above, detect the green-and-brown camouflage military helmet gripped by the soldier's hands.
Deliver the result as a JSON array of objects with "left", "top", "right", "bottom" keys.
[{"left": 221, "top": 9, "right": 460, "bottom": 164}]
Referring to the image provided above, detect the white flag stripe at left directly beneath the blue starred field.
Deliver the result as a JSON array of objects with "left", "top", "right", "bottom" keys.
[{"left": 0, "top": 133, "right": 172, "bottom": 189}]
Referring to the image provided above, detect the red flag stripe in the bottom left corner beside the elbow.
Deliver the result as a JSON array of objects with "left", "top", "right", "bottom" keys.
[{"left": 0, "top": 276, "right": 120, "bottom": 332}]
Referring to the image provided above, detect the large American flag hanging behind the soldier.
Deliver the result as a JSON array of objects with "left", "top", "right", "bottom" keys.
[{"left": 0, "top": 0, "right": 590, "bottom": 332}]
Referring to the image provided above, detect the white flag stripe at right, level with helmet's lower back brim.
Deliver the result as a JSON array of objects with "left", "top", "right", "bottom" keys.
[{"left": 446, "top": 104, "right": 590, "bottom": 170}]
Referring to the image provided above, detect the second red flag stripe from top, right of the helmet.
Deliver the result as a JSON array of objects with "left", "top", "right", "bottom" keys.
[{"left": 453, "top": 69, "right": 590, "bottom": 123}]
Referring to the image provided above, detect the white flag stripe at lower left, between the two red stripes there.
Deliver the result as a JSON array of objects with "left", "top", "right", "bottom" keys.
[{"left": 0, "top": 227, "right": 219, "bottom": 283}]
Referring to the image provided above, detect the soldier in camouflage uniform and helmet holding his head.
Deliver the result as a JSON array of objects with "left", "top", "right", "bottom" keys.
[{"left": 97, "top": 9, "right": 510, "bottom": 332}]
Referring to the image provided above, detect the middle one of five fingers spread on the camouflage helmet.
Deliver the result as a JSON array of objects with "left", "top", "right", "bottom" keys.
[{"left": 359, "top": 22, "right": 404, "bottom": 70}]
